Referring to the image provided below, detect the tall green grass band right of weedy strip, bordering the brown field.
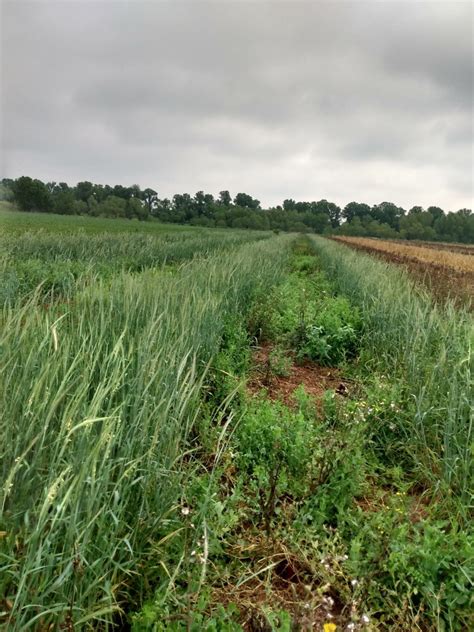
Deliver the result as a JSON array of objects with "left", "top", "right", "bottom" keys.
[{"left": 312, "top": 237, "right": 474, "bottom": 509}]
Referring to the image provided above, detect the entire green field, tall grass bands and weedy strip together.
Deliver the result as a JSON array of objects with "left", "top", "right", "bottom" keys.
[{"left": 0, "top": 211, "right": 474, "bottom": 632}]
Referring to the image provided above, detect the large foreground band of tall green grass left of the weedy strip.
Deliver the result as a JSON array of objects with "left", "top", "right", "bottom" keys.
[{"left": 0, "top": 237, "right": 289, "bottom": 630}]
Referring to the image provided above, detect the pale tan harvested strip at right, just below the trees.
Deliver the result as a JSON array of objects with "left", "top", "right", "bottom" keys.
[{"left": 336, "top": 237, "right": 474, "bottom": 274}]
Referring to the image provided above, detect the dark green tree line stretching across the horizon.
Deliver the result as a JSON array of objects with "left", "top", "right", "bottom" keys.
[{"left": 0, "top": 176, "right": 474, "bottom": 243}]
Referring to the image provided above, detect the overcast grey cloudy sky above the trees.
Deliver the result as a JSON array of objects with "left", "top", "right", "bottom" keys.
[{"left": 0, "top": 0, "right": 473, "bottom": 211}]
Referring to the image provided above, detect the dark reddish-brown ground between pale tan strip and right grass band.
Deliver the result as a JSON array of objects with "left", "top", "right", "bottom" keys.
[{"left": 338, "top": 240, "right": 474, "bottom": 310}]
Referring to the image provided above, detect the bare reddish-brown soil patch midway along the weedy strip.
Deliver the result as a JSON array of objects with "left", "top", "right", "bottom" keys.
[{"left": 248, "top": 344, "right": 349, "bottom": 406}]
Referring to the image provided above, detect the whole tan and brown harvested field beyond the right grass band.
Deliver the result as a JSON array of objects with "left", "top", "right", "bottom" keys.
[{"left": 336, "top": 237, "right": 474, "bottom": 306}]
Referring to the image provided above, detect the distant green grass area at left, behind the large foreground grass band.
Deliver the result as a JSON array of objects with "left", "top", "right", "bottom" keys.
[{"left": 0, "top": 229, "right": 269, "bottom": 304}]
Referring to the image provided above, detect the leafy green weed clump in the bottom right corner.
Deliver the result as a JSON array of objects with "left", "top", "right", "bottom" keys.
[{"left": 347, "top": 506, "right": 474, "bottom": 631}]
